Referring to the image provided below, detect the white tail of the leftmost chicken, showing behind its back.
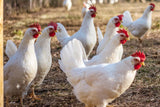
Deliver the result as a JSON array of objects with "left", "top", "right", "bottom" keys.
[{"left": 5, "top": 40, "right": 17, "bottom": 58}]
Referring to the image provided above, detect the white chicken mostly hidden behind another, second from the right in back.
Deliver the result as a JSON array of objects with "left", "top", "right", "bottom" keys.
[{"left": 96, "top": 15, "right": 123, "bottom": 54}]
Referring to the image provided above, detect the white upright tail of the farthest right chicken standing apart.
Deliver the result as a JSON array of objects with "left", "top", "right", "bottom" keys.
[{"left": 122, "top": 11, "right": 133, "bottom": 27}]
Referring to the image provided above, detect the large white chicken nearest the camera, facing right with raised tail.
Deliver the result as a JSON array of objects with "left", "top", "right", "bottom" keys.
[{"left": 59, "top": 40, "right": 145, "bottom": 107}]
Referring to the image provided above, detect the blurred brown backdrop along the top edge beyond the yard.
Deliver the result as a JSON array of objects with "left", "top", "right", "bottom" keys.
[{"left": 4, "top": 0, "right": 160, "bottom": 16}]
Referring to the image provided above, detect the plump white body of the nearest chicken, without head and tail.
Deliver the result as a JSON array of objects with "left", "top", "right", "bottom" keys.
[{"left": 73, "top": 59, "right": 136, "bottom": 107}]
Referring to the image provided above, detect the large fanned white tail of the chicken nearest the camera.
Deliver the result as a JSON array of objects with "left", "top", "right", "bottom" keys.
[{"left": 59, "top": 39, "right": 87, "bottom": 74}]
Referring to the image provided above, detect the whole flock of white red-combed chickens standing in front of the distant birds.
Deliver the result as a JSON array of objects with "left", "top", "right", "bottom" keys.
[{"left": 4, "top": 3, "right": 155, "bottom": 107}]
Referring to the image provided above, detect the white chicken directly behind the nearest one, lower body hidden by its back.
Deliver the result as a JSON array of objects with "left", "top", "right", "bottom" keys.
[{"left": 84, "top": 29, "right": 129, "bottom": 66}]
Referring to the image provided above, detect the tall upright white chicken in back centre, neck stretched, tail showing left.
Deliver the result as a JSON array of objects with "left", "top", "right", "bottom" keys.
[{"left": 56, "top": 6, "right": 97, "bottom": 57}]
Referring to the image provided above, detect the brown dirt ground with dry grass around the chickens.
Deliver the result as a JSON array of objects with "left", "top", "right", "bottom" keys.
[{"left": 4, "top": 3, "right": 160, "bottom": 107}]
